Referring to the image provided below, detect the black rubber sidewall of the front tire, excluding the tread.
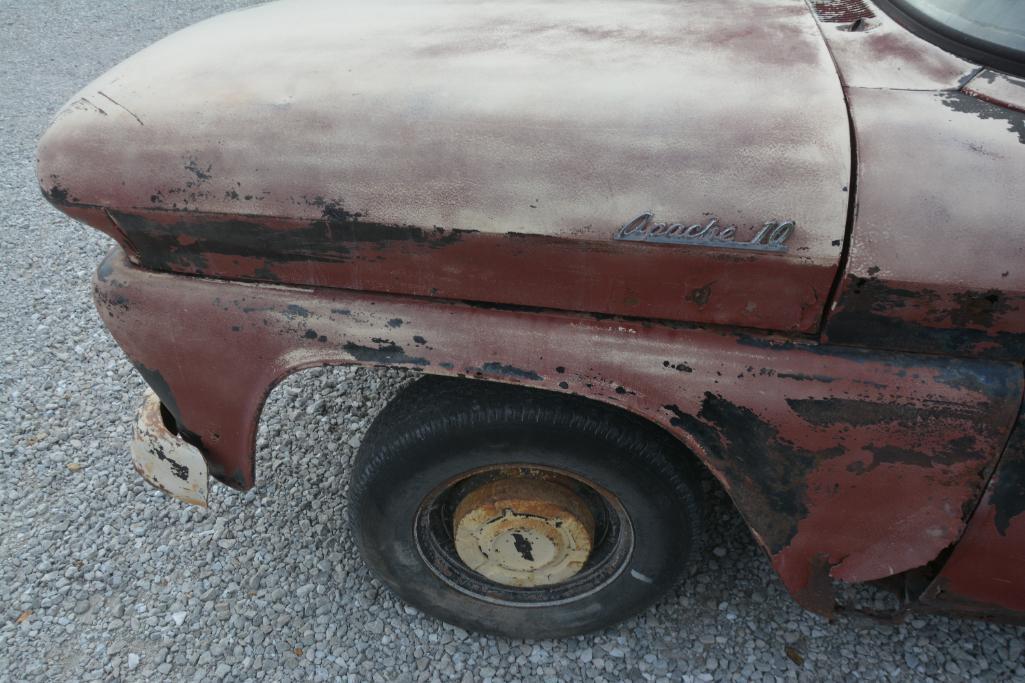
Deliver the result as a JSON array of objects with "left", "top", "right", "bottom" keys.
[{"left": 356, "top": 424, "right": 697, "bottom": 638}]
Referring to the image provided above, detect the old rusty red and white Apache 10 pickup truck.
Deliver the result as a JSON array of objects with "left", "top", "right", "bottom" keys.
[{"left": 38, "top": 0, "right": 1025, "bottom": 637}]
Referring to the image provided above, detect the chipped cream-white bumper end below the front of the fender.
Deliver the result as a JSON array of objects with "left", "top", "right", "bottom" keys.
[{"left": 131, "top": 390, "right": 210, "bottom": 508}]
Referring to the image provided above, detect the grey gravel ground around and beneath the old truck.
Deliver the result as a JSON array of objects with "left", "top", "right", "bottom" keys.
[{"left": 0, "top": 0, "right": 1025, "bottom": 681}]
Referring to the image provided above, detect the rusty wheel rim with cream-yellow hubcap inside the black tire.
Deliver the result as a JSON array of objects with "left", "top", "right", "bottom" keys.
[{"left": 414, "top": 465, "right": 633, "bottom": 606}]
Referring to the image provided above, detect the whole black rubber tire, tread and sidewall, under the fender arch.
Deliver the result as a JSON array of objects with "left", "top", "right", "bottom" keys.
[{"left": 349, "top": 376, "right": 702, "bottom": 639}]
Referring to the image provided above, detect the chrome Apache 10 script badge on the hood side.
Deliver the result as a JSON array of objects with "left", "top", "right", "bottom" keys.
[{"left": 613, "top": 211, "right": 795, "bottom": 251}]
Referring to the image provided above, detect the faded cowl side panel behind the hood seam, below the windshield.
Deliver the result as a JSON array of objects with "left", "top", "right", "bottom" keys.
[{"left": 825, "top": 88, "right": 1025, "bottom": 359}]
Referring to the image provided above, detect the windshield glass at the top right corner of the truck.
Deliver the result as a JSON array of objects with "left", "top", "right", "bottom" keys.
[{"left": 894, "top": 0, "right": 1025, "bottom": 61}]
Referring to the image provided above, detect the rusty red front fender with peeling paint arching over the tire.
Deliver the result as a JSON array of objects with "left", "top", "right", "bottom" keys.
[{"left": 95, "top": 250, "right": 1023, "bottom": 612}]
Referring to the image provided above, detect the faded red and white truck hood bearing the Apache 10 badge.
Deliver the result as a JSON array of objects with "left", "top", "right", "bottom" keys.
[{"left": 38, "top": 0, "right": 851, "bottom": 332}]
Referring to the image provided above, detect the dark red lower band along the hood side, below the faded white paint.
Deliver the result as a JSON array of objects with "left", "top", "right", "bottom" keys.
[{"left": 82, "top": 211, "right": 835, "bottom": 332}]
